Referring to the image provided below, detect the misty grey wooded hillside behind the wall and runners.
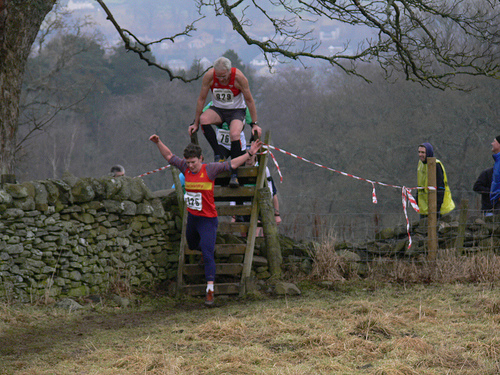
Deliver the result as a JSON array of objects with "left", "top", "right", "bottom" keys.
[{"left": 16, "top": 1, "right": 500, "bottom": 238}]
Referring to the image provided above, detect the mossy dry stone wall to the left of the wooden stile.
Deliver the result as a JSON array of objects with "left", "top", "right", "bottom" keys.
[{"left": 0, "top": 175, "right": 181, "bottom": 301}]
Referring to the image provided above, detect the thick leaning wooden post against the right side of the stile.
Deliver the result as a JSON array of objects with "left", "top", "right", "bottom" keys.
[{"left": 258, "top": 186, "right": 283, "bottom": 279}]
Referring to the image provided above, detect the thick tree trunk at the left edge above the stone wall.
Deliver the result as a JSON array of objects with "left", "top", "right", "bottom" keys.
[{"left": 0, "top": 0, "right": 56, "bottom": 175}]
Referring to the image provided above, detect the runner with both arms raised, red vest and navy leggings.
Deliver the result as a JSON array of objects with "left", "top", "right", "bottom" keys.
[{"left": 149, "top": 134, "right": 262, "bottom": 305}]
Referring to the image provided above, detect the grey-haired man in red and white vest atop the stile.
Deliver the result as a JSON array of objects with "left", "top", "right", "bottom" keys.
[{"left": 188, "top": 57, "right": 262, "bottom": 187}]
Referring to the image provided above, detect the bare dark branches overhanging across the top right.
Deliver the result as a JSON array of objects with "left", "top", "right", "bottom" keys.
[{"left": 97, "top": 0, "right": 500, "bottom": 89}]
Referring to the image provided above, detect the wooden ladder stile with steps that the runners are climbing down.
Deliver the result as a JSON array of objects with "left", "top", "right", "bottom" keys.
[{"left": 177, "top": 132, "right": 270, "bottom": 295}]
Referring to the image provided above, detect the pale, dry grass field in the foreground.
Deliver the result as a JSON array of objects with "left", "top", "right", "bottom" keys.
[{"left": 0, "top": 280, "right": 500, "bottom": 375}]
